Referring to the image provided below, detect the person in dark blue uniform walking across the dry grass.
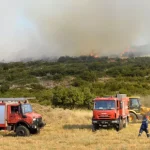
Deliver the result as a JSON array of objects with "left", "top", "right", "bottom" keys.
[{"left": 138, "top": 115, "right": 150, "bottom": 137}]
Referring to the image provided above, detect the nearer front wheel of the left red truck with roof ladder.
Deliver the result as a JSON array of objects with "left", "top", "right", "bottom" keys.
[{"left": 16, "top": 126, "right": 30, "bottom": 136}]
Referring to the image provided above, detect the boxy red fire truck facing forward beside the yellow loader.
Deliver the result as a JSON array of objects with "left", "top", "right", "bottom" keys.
[{"left": 92, "top": 94, "right": 129, "bottom": 131}]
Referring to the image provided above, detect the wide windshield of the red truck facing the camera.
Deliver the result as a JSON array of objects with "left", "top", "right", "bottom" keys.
[{"left": 94, "top": 100, "right": 115, "bottom": 110}]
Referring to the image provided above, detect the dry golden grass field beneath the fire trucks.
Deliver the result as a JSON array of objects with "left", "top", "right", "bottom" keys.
[{"left": 0, "top": 104, "right": 150, "bottom": 150}]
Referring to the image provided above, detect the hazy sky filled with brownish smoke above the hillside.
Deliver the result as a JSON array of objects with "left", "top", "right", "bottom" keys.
[{"left": 0, "top": 0, "right": 150, "bottom": 60}]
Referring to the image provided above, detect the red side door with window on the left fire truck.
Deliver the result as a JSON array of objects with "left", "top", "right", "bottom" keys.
[{"left": 8, "top": 106, "right": 21, "bottom": 123}]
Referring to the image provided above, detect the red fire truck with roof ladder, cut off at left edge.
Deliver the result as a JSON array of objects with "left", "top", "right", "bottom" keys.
[{"left": 0, "top": 98, "right": 45, "bottom": 136}]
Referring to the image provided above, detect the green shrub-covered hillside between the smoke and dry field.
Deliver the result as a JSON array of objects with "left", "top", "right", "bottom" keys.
[{"left": 0, "top": 56, "right": 150, "bottom": 108}]
